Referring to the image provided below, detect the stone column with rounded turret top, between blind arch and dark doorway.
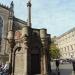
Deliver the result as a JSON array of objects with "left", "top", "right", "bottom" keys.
[{"left": 22, "top": 26, "right": 29, "bottom": 75}]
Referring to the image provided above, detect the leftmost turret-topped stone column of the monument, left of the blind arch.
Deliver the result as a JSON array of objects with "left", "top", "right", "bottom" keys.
[{"left": 7, "top": 30, "right": 15, "bottom": 75}]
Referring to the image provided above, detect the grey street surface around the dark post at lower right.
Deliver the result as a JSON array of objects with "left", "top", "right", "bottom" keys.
[{"left": 51, "top": 62, "right": 74, "bottom": 75}]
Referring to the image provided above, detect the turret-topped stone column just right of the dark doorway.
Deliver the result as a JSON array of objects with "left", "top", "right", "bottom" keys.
[{"left": 40, "top": 29, "right": 47, "bottom": 75}]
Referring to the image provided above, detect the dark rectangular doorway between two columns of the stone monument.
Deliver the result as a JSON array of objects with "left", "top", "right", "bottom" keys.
[{"left": 31, "top": 54, "right": 41, "bottom": 75}]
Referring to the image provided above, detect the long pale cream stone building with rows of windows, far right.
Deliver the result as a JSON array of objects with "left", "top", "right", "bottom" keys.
[{"left": 55, "top": 27, "right": 75, "bottom": 59}]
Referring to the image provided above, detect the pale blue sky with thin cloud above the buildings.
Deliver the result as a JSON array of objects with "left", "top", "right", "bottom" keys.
[{"left": 0, "top": 0, "right": 75, "bottom": 36}]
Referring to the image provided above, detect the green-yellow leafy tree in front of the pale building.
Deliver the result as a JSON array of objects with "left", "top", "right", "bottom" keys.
[{"left": 50, "top": 41, "right": 60, "bottom": 59}]
